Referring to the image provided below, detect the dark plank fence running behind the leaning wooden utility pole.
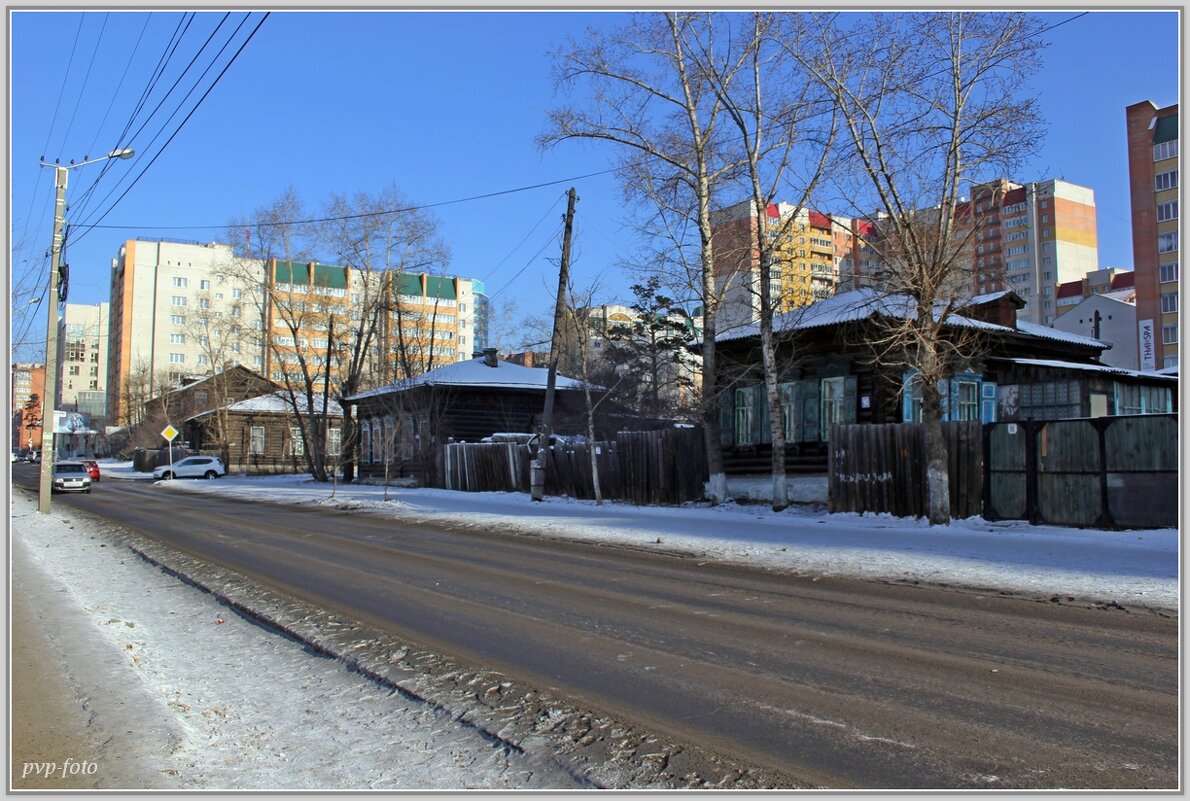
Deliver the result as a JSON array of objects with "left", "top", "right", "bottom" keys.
[{"left": 438, "top": 428, "right": 707, "bottom": 505}]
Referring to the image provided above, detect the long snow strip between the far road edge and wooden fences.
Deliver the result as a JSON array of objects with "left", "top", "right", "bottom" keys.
[{"left": 101, "top": 462, "right": 1179, "bottom": 609}]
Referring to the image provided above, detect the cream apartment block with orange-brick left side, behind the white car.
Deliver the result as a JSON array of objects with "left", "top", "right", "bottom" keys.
[{"left": 106, "top": 239, "right": 263, "bottom": 425}]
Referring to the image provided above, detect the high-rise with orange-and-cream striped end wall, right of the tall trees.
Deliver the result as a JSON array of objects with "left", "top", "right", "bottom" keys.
[{"left": 956, "top": 179, "right": 1098, "bottom": 325}]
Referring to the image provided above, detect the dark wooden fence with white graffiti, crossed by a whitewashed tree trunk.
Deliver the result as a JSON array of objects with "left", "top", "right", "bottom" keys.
[{"left": 827, "top": 420, "right": 983, "bottom": 519}]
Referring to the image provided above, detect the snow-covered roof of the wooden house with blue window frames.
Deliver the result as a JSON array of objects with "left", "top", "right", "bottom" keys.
[{"left": 715, "top": 287, "right": 1110, "bottom": 350}]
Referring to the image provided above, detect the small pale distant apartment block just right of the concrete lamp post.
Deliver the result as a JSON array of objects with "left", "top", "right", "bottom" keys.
[{"left": 55, "top": 302, "right": 111, "bottom": 425}]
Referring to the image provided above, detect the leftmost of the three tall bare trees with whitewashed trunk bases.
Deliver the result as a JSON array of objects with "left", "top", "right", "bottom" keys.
[{"left": 541, "top": 13, "right": 735, "bottom": 503}]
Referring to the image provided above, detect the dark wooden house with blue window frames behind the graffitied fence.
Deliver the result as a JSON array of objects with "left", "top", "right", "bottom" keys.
[{"left": 715, "top": 289, "right": 1177, "bottom": 473}]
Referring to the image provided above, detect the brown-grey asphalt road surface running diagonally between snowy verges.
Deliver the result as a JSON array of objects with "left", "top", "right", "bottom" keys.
[{"left": 14, "top": 470, "right": 1179, "bottom": 789}]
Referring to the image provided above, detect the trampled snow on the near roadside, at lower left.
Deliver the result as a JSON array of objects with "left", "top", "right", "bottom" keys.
[{"left": 11, "top": 487, "right": 571, "bottom": 790}]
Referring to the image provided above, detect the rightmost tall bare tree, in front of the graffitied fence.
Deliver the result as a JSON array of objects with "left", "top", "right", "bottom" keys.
[{"left": 804, "top": 12, "right": 1044, "bottom": 525}]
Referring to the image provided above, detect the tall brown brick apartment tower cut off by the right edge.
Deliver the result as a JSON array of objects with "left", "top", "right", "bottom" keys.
[{"left": 1126, "top": 100, "right": 1179, "bottom": 370}]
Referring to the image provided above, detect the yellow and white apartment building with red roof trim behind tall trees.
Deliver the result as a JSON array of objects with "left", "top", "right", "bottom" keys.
[{"left": 712, "top": 201, "right": 862, "bottom": 331}]
